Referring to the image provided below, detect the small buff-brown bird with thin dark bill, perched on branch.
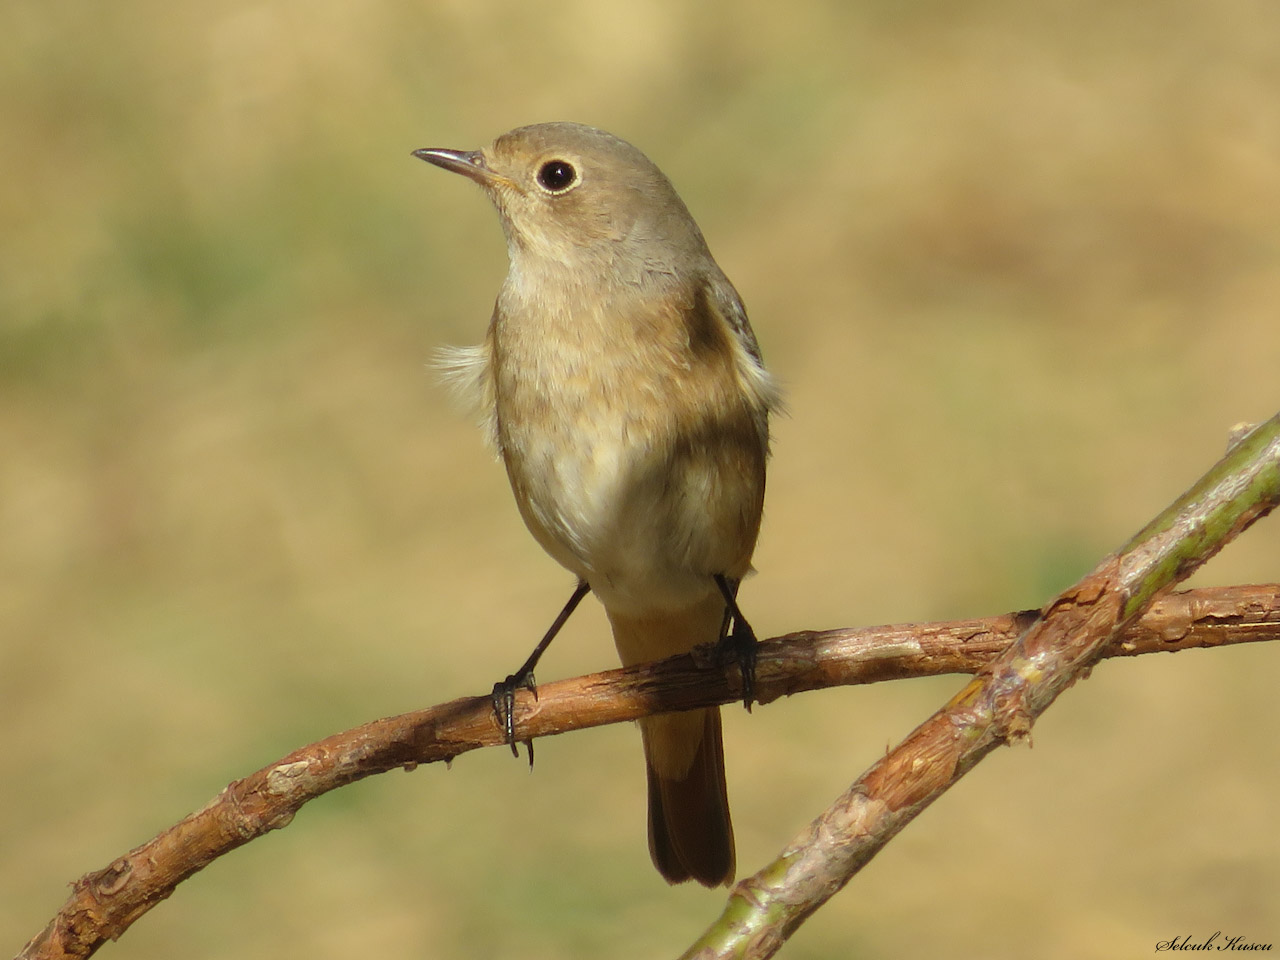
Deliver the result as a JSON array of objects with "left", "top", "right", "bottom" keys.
[{"left": 413, "top": 123, "right": 778, "bottom": 887}]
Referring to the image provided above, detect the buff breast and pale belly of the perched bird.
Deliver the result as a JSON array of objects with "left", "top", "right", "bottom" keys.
[{"left": 493, "top": 285, "right": 764, "bottom": 609}]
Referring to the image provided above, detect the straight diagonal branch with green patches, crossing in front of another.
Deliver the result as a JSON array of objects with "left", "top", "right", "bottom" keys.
[{"left": 685, "top": 415, "right": 1280, "bottom": 960}]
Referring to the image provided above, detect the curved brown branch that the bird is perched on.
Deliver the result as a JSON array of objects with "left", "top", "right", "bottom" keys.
[{"left": 19, "top": 584, "right": 1280, "bottom": 957}]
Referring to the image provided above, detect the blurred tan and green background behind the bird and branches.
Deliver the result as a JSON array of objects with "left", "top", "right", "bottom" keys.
[{"left": 0, "top": 0, "right": 1280, "bottom": 960}]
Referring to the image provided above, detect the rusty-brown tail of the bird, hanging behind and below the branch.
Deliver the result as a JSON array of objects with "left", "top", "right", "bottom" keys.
[{"left": 609, "top": 594, "right": 735, "bottom": 887}]
